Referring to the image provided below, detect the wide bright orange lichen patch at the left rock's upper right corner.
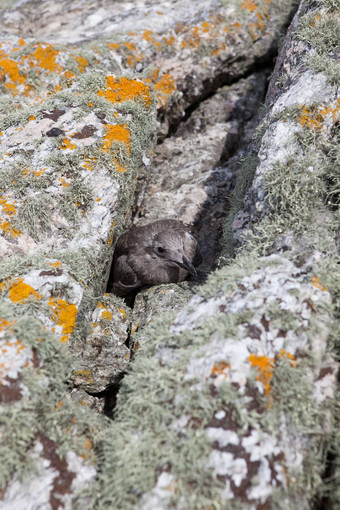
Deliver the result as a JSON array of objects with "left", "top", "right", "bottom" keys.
[{"left": 98, "top": 76, "right": 152, "bottom": 106}]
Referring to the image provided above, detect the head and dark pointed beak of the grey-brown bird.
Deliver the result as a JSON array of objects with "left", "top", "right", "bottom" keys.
[{"left": 152, "top": 232, "right": 197, "bottom": 277}]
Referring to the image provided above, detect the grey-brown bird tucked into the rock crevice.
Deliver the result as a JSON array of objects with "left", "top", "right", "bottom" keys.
[{"left": 112, "top": 219, "right": 202, "bottom": 297}]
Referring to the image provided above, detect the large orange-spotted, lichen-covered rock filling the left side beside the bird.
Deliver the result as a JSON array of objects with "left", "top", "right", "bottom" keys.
[{"left": 0, "top": 16, "right": 154, "bottom": 509}]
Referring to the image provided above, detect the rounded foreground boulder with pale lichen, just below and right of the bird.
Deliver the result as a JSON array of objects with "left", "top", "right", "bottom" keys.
[{"left": 97, "top": 255, "right": 337, "bottom": 509}]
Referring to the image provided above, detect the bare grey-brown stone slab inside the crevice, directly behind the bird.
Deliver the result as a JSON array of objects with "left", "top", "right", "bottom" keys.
[{"left": 134, "top": 71, "right": 267, "bottom": 273}]
